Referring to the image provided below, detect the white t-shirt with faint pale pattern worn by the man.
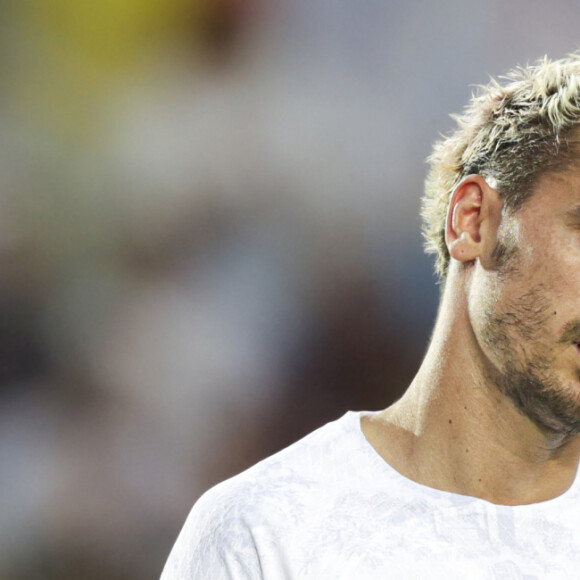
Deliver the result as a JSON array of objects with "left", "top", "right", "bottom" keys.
[{"left": 161, "top": 412, "right": 580, "bottom": 580}]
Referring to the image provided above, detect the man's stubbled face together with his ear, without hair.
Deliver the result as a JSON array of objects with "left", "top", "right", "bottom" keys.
[{"left": 450, "top": 169, "right": 580, "bottom": 437}]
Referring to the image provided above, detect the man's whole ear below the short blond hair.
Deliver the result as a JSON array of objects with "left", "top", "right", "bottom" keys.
[{"left": 445, "top": 175, "right": 503, "bottom": 263}]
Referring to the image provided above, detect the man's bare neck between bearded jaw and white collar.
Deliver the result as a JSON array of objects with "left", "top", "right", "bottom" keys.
[{"left": 363, "top": 274, "right": 580, "bottom": 505}]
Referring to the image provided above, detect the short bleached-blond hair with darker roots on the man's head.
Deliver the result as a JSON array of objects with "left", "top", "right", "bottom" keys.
[{"left": 421, "top": 53, "right": 580, "bottom": 279}]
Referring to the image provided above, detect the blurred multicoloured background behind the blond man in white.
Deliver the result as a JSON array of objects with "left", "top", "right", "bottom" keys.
[{"left": 0, "top": 0, "right": 580, "bottom": 580}]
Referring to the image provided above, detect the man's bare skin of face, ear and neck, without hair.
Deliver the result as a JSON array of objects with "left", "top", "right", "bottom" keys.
[{"left": 363, "top": 169, "right": 580, "bottom": 505}]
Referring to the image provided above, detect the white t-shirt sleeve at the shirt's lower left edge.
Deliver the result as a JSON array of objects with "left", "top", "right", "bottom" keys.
[{"left": 160, "top": 484, "right": 262, "bottom": 580}]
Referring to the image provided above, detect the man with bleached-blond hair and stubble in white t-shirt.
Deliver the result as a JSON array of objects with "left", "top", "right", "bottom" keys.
[{"left": 162, "top": 56, "right": 580, "bottom": 580}]
